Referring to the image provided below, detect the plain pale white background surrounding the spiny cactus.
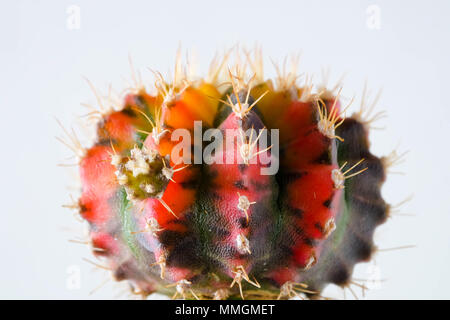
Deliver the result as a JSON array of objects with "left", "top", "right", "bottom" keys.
[{"left": 0, "top": 0, "right": 450, "bottom": 299}]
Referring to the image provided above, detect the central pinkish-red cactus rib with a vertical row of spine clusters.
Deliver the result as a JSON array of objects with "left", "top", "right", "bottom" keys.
[{"left": 208, "top": 111, "right": 274, "bottom": 276}]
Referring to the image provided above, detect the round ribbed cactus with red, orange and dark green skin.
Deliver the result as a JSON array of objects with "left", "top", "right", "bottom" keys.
[{"left": 74, "top": 52, "right": 389, "bottom": 299}]
